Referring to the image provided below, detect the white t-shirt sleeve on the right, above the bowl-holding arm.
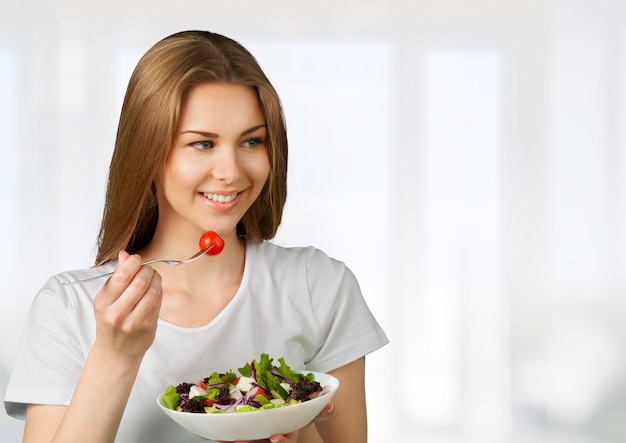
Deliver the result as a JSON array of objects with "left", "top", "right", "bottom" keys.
[{"left": 307, "top": 248, "right": 389, "bottom": 372}]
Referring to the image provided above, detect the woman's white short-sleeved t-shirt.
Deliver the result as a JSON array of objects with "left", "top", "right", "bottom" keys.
[{"left": 5, "top": 242, "right": 388, "bottom": 443}]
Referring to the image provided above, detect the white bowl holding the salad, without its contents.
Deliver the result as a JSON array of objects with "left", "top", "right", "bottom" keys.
[{"left": 157, "top": 371, "right": 339, "bottom": 441}]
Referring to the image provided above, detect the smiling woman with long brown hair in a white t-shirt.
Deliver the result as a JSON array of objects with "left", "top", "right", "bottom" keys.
[{"left": 5, "top": 31, "right": 387, "bottom": 443}]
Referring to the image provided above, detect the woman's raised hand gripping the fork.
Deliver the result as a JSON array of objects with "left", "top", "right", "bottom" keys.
[{"left": 94, "top": 251, "right": 162, "bottom": 360}]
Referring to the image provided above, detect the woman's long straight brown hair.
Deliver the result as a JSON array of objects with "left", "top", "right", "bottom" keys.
[{"left": 96, "top": 31, "right": 287, "bottom": 264}]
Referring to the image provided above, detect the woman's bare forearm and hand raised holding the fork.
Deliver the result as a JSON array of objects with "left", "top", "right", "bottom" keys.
[{"left": 24, "top": 253, "right": 161, "bottom": 443}]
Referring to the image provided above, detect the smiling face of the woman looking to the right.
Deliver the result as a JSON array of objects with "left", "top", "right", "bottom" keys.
[{"left": 155, "top": 83, "right": 271, "bottom": 241}]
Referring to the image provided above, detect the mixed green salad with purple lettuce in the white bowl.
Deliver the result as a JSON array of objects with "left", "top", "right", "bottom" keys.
[{"left": 163, "top": 354, "right": 326, "bottom": 414}]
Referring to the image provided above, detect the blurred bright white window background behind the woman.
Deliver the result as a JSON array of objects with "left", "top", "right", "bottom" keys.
[{"left": 0, "top": 0, "right": 626, "bottom": 443}]
